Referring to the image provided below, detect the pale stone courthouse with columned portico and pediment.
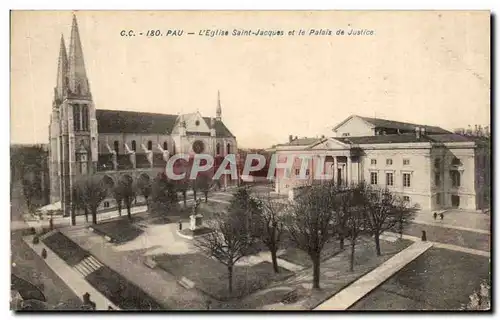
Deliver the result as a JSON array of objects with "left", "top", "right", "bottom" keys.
[{"left": 275, "top": 115, "right": 491, "bottom": 210}]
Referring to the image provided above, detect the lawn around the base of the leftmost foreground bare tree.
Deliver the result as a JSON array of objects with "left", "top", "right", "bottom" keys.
[{"left": 155, "top": 253, "right": 293, "bottom": 301}]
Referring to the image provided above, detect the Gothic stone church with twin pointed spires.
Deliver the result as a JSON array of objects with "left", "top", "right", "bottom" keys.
[{"left": 49, "top": 16, "right": 237, "bottom": 215}]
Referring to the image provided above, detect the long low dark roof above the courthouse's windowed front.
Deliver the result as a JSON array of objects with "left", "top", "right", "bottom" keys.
[{"left": 334, "top": 133, "right": 474, "bottom": 144}]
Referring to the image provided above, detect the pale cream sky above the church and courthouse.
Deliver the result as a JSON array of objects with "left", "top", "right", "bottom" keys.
[{"left": 10, "top": 11, "right": 490, "bottom": 148}]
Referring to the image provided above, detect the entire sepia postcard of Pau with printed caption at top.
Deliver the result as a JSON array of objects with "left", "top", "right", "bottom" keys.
[{"left": 10, "top": 11, "right": 491, "bottom": 312}]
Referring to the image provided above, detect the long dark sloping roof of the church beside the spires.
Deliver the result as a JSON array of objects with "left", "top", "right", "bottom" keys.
[{"left": 96, "top": 109, "right": 234, "bottom": 138}]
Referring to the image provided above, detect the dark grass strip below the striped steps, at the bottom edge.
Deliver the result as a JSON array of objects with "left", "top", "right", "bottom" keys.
[{"left": 85, "top": 267, "right": 168, "bottom": 310}]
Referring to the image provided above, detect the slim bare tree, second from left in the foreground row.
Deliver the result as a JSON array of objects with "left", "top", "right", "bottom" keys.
[{"left": 255, "top": 195, "right": 289, "bottom": 273}]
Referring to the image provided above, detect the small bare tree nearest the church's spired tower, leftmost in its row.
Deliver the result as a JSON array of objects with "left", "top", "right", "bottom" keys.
[{"left": 77, "top": 176, "right": 107, "bottom": 224}]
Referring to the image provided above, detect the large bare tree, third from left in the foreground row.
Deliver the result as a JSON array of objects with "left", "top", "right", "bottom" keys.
[{"left": 286, "top": 183, "right": 339, "bottom": 288}]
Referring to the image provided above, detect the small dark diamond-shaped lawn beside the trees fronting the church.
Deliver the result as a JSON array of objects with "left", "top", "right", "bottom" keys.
[{"left": 92, "top": 217, "right": 144, "bottom": 243}]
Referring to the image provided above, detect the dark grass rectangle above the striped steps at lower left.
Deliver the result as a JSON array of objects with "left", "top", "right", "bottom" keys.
[{"left": 42, "top": 232, "right": 90, "bottom": 267}]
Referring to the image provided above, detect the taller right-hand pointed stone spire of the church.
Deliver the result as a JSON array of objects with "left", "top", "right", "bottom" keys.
[{"left": 68, "top": 15, "right": 90, "bottom": 96}]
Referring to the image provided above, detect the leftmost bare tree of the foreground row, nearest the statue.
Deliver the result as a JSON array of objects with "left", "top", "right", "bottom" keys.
[{"left": 195, "top": 212, "right": 249, "bottom": 293}]
